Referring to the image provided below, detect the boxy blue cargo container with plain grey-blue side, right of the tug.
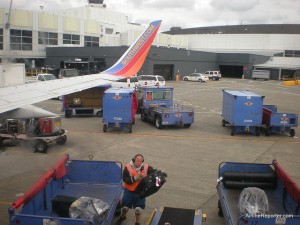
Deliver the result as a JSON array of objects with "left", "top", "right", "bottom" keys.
[{"left": 222, "top": 90, "right": 264, "bottom": 136}]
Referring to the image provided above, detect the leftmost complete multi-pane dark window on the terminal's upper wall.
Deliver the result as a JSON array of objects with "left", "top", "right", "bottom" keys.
[{"left": 10, "top": 29, "right": 32, "bottom": 51}]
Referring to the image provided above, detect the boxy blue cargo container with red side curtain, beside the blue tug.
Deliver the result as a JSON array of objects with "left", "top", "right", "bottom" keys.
[{"left": 103, "top": 88, "right": 137, "bottom": 133}]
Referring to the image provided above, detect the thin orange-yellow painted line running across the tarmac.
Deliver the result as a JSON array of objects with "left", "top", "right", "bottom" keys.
[{"left": 69, "top": 131, "right": 300, "bottom": 144}]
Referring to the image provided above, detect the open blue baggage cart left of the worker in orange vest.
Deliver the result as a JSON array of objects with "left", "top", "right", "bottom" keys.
[{"left": 8, "top": 156, "right": 123, "bottom": 225}]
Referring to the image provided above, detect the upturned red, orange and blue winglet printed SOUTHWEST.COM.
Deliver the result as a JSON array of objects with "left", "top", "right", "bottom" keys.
[{"left": 102, "top": 20, "right": 162, "bottom": 77}]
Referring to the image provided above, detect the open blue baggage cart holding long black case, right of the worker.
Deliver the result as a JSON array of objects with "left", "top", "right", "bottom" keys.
[{"left": 217, "top": 160, "right": 300, "bottom": 225}]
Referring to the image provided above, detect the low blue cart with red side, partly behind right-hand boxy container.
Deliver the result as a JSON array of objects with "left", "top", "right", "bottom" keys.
[{"left": 262, "top": 105, "right": 298, "bottom": 137}]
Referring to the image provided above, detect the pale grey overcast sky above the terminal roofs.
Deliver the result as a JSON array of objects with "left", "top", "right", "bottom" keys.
[{"left": 0, "top": 0, "right": 300, "bottom": 31}]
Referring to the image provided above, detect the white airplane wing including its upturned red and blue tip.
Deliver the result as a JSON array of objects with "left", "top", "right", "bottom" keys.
[{"left": 0, "top": 20, "right": 161, "bottom": 118}]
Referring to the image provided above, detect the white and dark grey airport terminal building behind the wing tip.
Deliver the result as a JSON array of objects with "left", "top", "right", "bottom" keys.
[{"left": 0, "top": 0, "right": 300, "bottom": 80}]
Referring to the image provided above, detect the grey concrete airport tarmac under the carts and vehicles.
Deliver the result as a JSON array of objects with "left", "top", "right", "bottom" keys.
[{"left": 0, "top": 78, "right": 300, "bottom": 225}]
